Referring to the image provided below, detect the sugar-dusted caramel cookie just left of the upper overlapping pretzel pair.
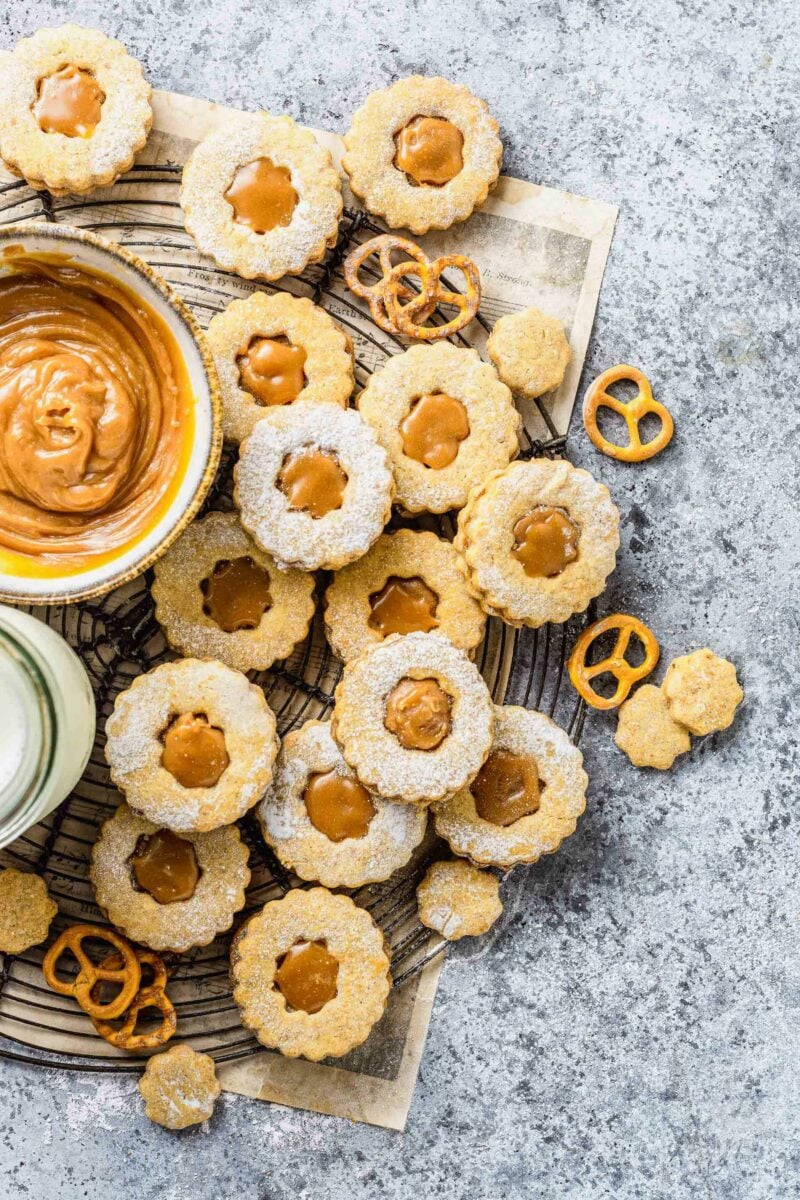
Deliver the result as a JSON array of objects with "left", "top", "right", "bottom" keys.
[{"left": 180, "top": 113, "right": 342, "bottom": 280}]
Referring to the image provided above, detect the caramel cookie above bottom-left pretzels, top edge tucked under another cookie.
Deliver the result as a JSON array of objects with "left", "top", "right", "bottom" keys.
[{"left": 89, "top": 804, "right": 249, "bottom": 954}]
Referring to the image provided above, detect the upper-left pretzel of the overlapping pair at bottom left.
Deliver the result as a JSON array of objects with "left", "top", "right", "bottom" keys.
[{"left": 42, "top": 925, "right": 142, "bottom": 1020}]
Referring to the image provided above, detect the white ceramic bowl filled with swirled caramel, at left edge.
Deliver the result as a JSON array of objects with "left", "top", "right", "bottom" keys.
[{"left": 0, "top": 224, "right": 222, "bottom": 604}]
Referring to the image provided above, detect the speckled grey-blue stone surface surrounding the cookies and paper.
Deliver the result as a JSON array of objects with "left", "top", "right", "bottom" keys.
[{"left": 0, "top": 0, "right": 800, "bottom": 1200}]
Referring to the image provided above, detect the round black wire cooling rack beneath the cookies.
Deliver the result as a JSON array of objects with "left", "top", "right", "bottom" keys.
[{"left": 0, "top": 164, "right": 585, "bottom": 1072}]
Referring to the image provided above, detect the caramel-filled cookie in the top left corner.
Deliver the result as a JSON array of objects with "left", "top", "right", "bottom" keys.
[{"left": 0, "top": 25, "right": 152, "bottom": 196}]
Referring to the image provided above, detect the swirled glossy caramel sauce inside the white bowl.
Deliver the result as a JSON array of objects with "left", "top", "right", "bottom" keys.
[{"left": 0, "top": 247, "right": 194, "bottom": 577}]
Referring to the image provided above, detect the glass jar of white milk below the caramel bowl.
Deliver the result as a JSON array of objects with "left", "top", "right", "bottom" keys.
[{"left": 0, "top": 605, "right": 96, "bottom": 847}]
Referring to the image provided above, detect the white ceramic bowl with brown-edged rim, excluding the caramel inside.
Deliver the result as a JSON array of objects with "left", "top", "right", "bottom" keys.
[{"left": 0, "top": 224, "right": 222, "bottom": 604}]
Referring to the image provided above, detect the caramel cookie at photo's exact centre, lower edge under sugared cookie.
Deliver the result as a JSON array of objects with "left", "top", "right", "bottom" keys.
[{"left": 325, "top": 529, "right": 486, "bottom": 662}]
